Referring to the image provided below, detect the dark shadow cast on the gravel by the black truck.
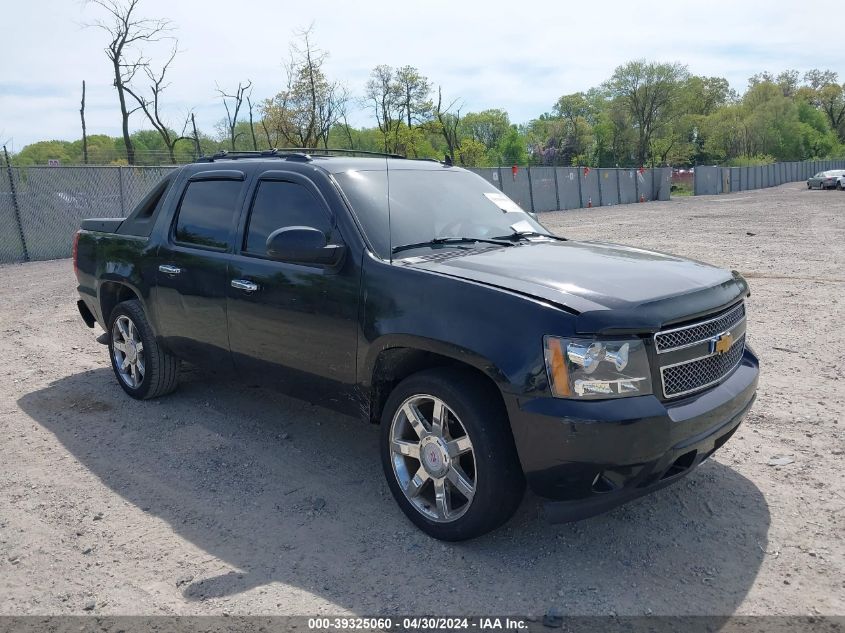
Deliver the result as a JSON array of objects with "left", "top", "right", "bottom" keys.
[{"left": 18, "top": 369, "right": 770, "bottom": 615}]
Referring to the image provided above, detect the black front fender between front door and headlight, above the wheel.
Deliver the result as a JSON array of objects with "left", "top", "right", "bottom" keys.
[{"left": 358, "top": 257, "right": 574, "bottom": 395}]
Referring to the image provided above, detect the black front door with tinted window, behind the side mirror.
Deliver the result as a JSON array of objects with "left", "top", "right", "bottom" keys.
[{"left": 226, "top": 171, "right": 360, "bottom": 410}]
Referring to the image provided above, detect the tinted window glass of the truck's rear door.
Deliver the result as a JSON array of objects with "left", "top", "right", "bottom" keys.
[{"left": 175, "top": 180, "right": 243, "bottom": 249}]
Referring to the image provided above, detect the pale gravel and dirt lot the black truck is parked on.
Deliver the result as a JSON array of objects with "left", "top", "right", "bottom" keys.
[{"left": 0, "top": 184, "right": 845, "bottom": 615}]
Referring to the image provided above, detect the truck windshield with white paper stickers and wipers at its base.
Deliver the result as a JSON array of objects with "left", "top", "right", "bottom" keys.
[{"left": 335, "top": 167, "right": 548, "bottom": 259}]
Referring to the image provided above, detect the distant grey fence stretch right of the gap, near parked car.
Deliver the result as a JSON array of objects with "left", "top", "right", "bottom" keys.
[{"left": 695, "top": 159, "right": 845, "bottom": 196}]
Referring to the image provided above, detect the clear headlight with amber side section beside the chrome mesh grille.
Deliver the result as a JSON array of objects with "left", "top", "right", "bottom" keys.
[{"left": 543, "top": 336, "right": 651, "bottom": 400}]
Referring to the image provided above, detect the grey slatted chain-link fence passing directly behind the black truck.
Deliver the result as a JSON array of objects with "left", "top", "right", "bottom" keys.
[{"left": 0, "top": 162, "right": 671, "bottom": 263}]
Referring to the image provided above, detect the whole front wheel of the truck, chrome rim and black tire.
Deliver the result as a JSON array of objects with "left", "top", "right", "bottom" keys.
[{"left": 381, "top": 368, "right": 525, "bottom": 541}]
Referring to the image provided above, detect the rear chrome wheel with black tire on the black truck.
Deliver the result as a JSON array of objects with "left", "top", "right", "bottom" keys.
[{"left": 107, "top": 299, "right": 179, "bottom": 400}]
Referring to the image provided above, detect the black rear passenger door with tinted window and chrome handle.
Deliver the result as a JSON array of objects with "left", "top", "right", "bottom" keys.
[{"left": 155, "top": 170, "right": 245, "bottom": 370}]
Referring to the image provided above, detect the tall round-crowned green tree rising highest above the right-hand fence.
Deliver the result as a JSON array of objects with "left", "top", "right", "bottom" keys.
[{"left": 606, "top": 60, "right": 689, "bottom": 165}]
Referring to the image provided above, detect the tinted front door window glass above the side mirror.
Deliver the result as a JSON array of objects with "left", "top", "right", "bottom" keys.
[{"left": 244, "top": 180, "right": 331, "bottom": 255}]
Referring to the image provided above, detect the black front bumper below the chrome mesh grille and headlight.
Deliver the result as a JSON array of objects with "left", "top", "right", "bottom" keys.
[{"left": 508, "top": 348, "right": 759, "bottom": 521}]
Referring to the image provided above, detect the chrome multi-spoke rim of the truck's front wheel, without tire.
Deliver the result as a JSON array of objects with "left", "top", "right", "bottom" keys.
[{"left": 390, "top": 394, "right": 476, "bottom": 523}]
